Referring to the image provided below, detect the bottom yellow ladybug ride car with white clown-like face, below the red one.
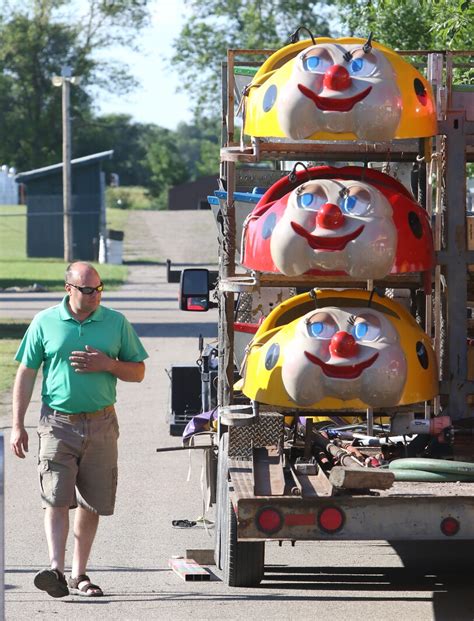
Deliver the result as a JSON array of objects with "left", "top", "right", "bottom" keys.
[{"left": 242, "top": 290, "right": 438, "bottom": 410}]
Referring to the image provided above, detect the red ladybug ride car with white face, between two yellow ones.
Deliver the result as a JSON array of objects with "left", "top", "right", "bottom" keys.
[{"left": 242, "top": 166, "right": 435, "bottom": 279}]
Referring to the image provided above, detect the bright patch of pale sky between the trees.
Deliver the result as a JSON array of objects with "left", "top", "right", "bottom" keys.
[{"left": 95, "top": 0, "right": 192, "bottom": 129}]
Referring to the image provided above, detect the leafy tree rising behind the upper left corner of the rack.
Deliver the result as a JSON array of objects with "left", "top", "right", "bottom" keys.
[{"left": 171, "top": 0, "right": 332, "bottom": 118}]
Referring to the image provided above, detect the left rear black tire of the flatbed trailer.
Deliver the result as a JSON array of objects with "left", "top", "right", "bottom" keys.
[{"left": 215, "top": 433, "right": 265, "bottom": 587}]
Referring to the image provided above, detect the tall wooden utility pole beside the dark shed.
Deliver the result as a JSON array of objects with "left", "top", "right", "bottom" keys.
[{"left": 52, "top": 66, "right": 79, "bottom": 263}]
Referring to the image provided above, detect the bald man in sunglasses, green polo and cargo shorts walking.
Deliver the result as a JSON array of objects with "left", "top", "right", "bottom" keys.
[{"left": 11, "top": 262, "right": 148, "bottom": 597}]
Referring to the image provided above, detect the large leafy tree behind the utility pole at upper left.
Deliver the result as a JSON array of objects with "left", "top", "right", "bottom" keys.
[{"left": 0, "top": 0, "right": 148, "bottom": 170}]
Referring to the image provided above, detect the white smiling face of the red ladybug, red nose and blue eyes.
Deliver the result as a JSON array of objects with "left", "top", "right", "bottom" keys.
[{"left": 270, "top": 179, "right": 397, "bottom": 278}]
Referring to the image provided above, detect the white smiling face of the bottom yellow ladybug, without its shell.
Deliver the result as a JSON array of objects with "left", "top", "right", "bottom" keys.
[{"left": 282, "top": 307, "right": 407, "bottom": 407}]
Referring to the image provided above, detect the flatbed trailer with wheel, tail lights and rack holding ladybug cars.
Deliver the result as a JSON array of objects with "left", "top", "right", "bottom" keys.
[{"left": 178, "top": 43, "right": 474, "bottom": 586}]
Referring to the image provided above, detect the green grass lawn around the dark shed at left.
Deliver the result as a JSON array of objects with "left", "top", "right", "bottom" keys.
[{"left": 0, "top": 205, "right": 128, "bottom": 291}]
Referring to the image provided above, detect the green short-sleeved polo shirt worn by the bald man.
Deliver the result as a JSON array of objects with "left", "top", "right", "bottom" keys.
[{"left": 15, "top": 296, "right": 148, "bottom": 414}]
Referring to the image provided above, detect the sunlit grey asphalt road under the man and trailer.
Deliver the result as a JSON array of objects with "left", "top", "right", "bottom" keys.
[{"left": 0, "top": 214, "right": 474, "bottom": 621}]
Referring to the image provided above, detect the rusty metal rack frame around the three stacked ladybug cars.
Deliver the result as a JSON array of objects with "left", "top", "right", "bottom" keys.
[{"left": 218, "top": 50, "right": 474, "bottom": 420}]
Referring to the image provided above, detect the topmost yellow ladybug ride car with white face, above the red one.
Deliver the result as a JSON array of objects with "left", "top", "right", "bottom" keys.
[{"left": 244, "top": 38, "right": 436, "bottom": 141}]
